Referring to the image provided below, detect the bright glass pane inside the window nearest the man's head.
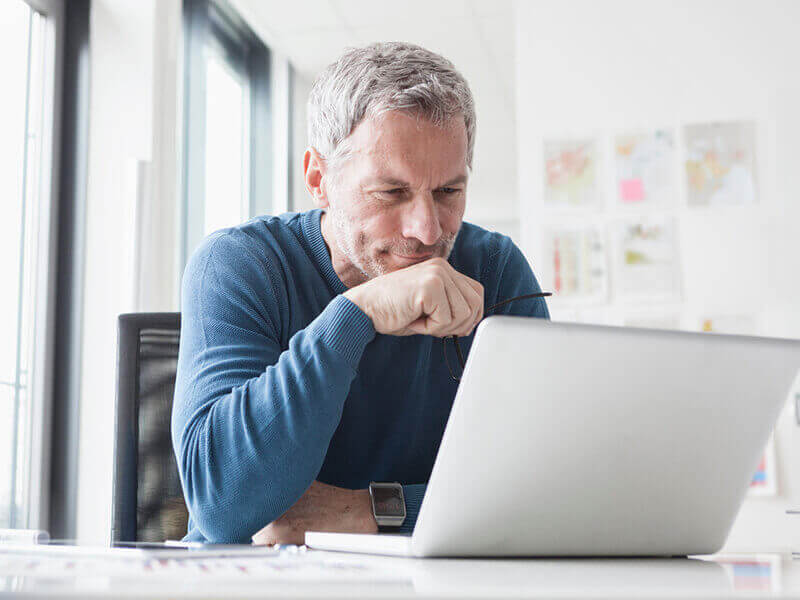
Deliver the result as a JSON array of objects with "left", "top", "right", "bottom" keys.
[{"left": 204, "top": 51, "right": 249, "bottom": 235}]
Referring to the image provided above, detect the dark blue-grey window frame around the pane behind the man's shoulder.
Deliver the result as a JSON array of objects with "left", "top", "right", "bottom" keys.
[{"left": 180, "top": 0, "right": 274, "bottom": 270}]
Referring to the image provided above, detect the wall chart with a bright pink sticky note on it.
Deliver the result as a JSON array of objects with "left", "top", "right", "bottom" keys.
[{"left": 614, "top": 130, "right": 677, "bottom": 206}]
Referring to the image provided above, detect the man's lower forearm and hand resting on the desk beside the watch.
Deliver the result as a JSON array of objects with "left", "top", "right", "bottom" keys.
[{"left": 253, "top": 481, "right": 378, "bottom": 546}]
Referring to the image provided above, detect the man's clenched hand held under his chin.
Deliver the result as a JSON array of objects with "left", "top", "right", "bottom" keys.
[{"left": 344, "top": 257, "right": 483, "bottom": 337}]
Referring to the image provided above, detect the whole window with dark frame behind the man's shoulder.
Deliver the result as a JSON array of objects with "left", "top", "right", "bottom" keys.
[{"left": 183, "top": 0, "right": 272, "bottom": 262}]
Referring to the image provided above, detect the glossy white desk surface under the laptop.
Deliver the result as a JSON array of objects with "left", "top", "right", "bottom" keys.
[{"left": 0, "top": 548, "right": 800, "bottom": 599}]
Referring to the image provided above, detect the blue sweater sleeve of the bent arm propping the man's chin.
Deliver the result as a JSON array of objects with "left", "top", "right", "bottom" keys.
[{"left": 172, "top": 234, "right": 375, "bottom": 543}]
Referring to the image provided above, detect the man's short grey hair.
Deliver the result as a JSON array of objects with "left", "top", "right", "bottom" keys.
[{"left": 308, "top": 42, "right": 475, "bottom": 170}]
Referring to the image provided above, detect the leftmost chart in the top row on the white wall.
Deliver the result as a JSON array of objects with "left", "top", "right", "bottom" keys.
[{"left": 544, "top": 139, "right": 600, "bottom": 208}]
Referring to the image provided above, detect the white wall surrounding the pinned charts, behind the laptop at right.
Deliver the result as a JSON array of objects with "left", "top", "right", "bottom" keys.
[{"left": 515, "top": 0, "right": 800, "bottom": 550}]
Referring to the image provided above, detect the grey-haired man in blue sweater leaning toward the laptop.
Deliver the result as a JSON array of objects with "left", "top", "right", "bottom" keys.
[{"left": 172, "top": 43, "right": 549, "bottom": 544}]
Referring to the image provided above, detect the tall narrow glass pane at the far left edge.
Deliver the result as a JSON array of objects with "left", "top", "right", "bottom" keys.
[{"left": 0, "top": 0, "right": 44, "bottom": 527}]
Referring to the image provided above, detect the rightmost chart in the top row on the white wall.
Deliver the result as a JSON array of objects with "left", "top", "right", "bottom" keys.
[{"left": 684, "top": 121, "right": 756, "bottom": 206}]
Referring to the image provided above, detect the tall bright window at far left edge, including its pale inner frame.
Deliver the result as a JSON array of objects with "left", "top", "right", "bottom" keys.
[{"left": 0, "top": 0, "right": 60, "bottom": 527}]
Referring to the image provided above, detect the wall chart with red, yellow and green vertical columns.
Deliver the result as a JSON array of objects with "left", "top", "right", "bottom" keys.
[{"left": 545, "top": 227, "right": 608, "bottom": 303}]
